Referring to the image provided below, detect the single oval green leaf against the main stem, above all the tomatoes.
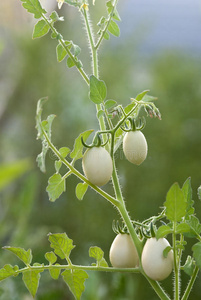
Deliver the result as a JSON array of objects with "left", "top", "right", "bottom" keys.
[{"left": 89, "top": 75, "right": 107, "bottom": 104}]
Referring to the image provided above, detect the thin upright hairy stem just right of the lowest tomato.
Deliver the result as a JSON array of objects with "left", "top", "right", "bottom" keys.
[{"left": 172, "top": 222, "right": 180, "bottom": 300}]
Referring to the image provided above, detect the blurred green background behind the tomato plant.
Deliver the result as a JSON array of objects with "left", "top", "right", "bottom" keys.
[{"left": 0, "top": 0, "right": 201, "bottom": 300}]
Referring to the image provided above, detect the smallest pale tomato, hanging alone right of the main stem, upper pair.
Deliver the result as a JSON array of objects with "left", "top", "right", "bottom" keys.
[{"left": 123, "top": 130, "right": 148, "bottom": 165}]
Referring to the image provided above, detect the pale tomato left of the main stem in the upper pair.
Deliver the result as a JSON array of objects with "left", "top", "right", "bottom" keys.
[{"left": 82, "top": 147, "right": 113, "bottom": 186}]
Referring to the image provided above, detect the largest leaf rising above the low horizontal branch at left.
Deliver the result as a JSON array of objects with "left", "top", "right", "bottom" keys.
[{"left": 48, "top": 233, "right": 75, "bottom": 259}]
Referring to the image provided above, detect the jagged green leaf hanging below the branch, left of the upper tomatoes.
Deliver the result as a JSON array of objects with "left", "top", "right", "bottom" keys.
[{"left": 46, "top": 173, "right": 66, "bottom": 202}]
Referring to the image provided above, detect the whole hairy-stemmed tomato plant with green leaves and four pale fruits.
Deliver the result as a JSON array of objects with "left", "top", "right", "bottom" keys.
[{"left": 0, "top": 0, "right": 201, "bottom": 300}]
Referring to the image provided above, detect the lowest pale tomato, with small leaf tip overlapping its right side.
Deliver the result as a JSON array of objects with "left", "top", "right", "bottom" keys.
[{"left": 142, "top": 238, "right": 174, "bottom": 281}]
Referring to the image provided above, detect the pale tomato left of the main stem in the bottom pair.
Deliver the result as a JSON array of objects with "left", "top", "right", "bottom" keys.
[{"left": 110, "top": 233, "right": 139, "bottom": 268}]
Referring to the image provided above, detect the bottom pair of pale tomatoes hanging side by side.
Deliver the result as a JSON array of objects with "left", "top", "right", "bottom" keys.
[{"left": 109, "top": 233, "right": 173, "bottom": 281}]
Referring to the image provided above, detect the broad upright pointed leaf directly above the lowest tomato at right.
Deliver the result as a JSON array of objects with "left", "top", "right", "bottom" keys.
[{"left": 164, "top": 183, "right": 187, "bottom": 222}]
